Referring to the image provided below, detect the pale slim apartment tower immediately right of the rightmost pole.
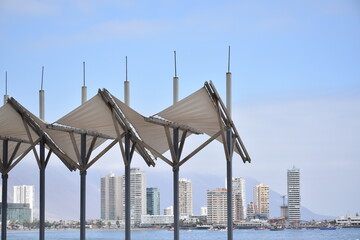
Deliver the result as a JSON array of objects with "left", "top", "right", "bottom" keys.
[{"left": 232, "top": 177, "right": 246, "bottom": 221}]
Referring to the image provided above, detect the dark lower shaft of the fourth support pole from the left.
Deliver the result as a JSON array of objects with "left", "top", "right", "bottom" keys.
[{"left": 125, "top": 133, "right": 131, "bottom": 240}]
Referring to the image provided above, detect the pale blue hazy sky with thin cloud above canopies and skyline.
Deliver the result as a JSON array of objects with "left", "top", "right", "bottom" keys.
[{"left": 0, "top": 0, "right": 360, "bottom": 219}]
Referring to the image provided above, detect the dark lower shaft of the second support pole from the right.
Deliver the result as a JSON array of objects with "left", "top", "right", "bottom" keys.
[{"left": 173, "top": 128, "right": 180, "bottom": 240}]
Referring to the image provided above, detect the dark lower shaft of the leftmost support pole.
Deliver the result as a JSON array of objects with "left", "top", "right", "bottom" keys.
[{"left": 1, "top": 140, "right": 9, "bottom": 240}]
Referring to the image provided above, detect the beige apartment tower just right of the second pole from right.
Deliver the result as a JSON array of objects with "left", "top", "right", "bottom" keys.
[{"left": 179, "top": 178, "right": 193, "bottom": 216}]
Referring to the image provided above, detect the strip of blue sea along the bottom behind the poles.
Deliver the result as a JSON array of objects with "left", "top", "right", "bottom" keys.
[{"left": 7, "top": 228, "right": 360, "bottom": 240}]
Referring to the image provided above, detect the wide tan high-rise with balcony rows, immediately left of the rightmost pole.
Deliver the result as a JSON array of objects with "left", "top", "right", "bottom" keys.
[{"left": 206, "top": 188, "right": 227, "bottom": 225}]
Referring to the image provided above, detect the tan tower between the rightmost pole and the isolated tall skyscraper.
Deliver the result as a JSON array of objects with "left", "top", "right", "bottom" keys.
[{"left": 254, "top": 184, "right": 270, "bottom": 217}]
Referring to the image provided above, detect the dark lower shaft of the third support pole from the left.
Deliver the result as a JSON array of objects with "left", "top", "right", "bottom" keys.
[{"left": 80, "top": 134, "right": 87, "bottom": 240}]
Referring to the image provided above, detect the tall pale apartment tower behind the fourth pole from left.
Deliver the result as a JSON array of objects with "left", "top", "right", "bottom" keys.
[{"left": 122, "top": 168, "right": 146, "bottom": 225}]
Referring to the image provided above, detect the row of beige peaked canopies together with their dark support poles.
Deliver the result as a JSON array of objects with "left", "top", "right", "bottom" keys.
[{"left": 0, "top": 82, "right": 250, "bottom": 240}]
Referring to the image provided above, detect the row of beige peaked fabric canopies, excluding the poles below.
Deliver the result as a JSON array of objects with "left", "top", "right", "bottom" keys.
[{"left": 0, "top": 82, "right": 250, "bottom": 174}]
